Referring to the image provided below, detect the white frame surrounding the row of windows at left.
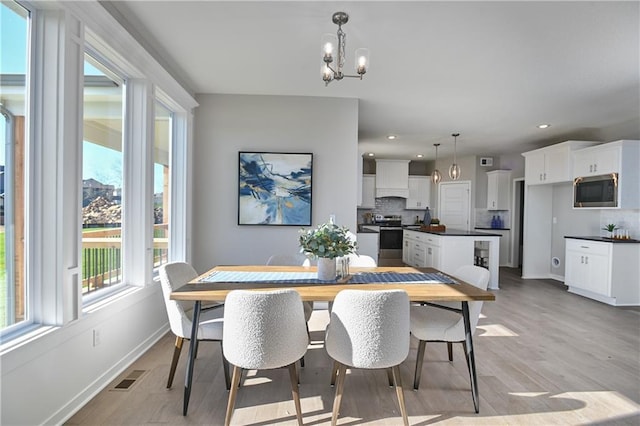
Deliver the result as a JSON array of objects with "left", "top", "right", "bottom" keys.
[{"left": 0, "top": 1, "right": 197, "bottom": 342}]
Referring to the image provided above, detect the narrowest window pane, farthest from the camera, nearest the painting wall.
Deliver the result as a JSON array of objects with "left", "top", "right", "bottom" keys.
[{"left": 153, "top": 101, "right": 173, "bottom": 268}]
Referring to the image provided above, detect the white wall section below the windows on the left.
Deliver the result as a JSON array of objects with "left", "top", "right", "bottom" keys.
[{"left": 0, "top": 284, "right": 166, "bottom": 425}]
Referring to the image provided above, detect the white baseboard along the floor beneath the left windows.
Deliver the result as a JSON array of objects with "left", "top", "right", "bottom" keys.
[{"left": 43, "top": 323, "right": 169, "bottom": 425}]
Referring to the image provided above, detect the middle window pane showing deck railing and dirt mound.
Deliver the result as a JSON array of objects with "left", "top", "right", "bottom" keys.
[{"left": 82, "top": 54, "right": 124, "bottom": 295}]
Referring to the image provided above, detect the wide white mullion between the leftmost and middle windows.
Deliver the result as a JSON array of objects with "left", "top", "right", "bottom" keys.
[{"left": 27, "top": 10, "right": 83, "bottom": 325}]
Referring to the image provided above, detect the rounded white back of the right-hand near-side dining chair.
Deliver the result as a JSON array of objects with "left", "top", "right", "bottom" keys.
[{"left": 325, "top": 290, "right": 409, "bottom": 368}]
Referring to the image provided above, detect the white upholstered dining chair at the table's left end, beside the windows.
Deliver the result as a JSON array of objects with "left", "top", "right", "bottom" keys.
[{"left": 160, "top": 262, "right": 230, "bottom": 390}]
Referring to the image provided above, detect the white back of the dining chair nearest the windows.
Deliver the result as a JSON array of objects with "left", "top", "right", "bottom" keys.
[{"left": 160, "top": 262, "right": 198, "bottom": 338}]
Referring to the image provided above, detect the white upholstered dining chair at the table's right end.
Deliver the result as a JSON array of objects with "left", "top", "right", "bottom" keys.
[{"left": 411, "top": 265, "right": 490, "bottom": 389}]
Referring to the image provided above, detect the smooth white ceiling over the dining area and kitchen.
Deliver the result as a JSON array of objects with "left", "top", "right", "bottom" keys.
[{"left": 102, "top": 1, "right": 640, "bottom": 160}]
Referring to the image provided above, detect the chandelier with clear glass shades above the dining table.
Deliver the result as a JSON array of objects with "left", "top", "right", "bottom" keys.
[{"left": 322, "top": 12, "right": 369, "bottom": 86}]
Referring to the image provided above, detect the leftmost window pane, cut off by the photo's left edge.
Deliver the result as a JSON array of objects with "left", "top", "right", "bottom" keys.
[{"left": 0, "top": 2, "right": 29, "bottom": 330}]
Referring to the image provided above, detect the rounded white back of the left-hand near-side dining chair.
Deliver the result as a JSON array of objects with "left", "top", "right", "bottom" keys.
[{"left": 222, "top": 289, "right": 309, "bottom": 370}]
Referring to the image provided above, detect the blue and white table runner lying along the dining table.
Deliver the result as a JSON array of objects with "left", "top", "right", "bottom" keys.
[{"left": 200, "top": 271, "right": 457, "bottom": 284}]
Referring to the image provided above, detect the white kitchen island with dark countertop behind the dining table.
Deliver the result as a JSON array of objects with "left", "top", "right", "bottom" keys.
[{"left": 402, "top": 229, "right": 501, "bottom": 290}]
